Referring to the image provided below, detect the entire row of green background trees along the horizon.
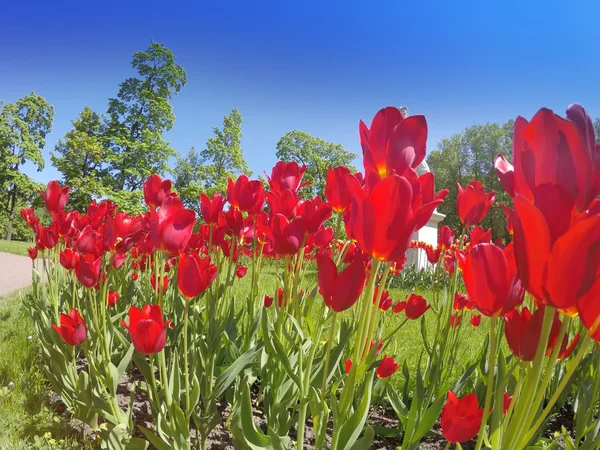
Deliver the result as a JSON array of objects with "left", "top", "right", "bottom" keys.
[{"left": 0, "top": 42, "right": 600, "bottom": 240}]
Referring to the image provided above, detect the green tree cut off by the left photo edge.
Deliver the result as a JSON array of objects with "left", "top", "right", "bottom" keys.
[{"left": 0, "top": 92, "right": 54, "bottom": 240}]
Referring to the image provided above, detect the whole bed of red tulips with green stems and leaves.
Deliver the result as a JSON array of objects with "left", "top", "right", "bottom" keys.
[{"left": 21, "top": 105, "right": 600, "bottom": 450}]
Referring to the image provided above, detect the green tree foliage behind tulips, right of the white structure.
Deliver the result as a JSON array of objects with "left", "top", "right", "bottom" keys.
[{"left": 427, "top": 121, "right": 514, "bottom": 239}]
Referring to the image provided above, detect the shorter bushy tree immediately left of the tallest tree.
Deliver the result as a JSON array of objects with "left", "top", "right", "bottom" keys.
[{"left": 51, "top": 106, "right": 110, "bottom": 211}]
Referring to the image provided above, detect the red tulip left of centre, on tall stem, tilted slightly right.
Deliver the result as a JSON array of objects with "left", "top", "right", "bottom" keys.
[{"left": 177, "top": 252, "right": 218, "bottom": 298}]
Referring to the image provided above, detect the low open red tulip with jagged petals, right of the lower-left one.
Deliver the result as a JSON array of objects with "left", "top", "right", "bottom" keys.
[{"left": 121, "top": 305, "right": 171, "bottom": 355}]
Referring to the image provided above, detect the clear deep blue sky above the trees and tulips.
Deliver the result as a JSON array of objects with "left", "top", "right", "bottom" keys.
[{"left": 0, "top": 0, "right": 600, "bottom": 181}]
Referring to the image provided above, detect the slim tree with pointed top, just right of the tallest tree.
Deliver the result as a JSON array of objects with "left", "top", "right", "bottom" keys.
[{"left": 196, "top": 108, "right": 252, "bottom": 194}]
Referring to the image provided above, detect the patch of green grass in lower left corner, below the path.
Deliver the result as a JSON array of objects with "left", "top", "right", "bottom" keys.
[{"left": 0, "top": 289, "right": 81, "bottom": 450}]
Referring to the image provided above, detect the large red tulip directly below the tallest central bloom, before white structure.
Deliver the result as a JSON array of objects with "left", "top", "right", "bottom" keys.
[{"left": 346, "top": 175, "right": 445, "bottom": 261}]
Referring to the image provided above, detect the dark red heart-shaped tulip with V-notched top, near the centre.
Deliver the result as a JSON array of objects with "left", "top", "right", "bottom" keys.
[{"left": 317, "top": 254, "right": 366, "bottom": 312}]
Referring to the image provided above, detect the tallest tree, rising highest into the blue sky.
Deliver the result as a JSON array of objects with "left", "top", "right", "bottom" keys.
[{"left": 106, "top": 42, "right": 187, "bottom": 198}]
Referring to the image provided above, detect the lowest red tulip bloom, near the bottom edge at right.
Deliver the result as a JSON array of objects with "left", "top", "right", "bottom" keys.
[{"left": 440, "top": 391, "right": 483, "bottom": 443}]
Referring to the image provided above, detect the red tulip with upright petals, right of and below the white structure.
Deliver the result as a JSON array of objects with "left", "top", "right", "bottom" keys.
[{"left": 458, "top": 244, "right": 525, "bottom": 317}]
